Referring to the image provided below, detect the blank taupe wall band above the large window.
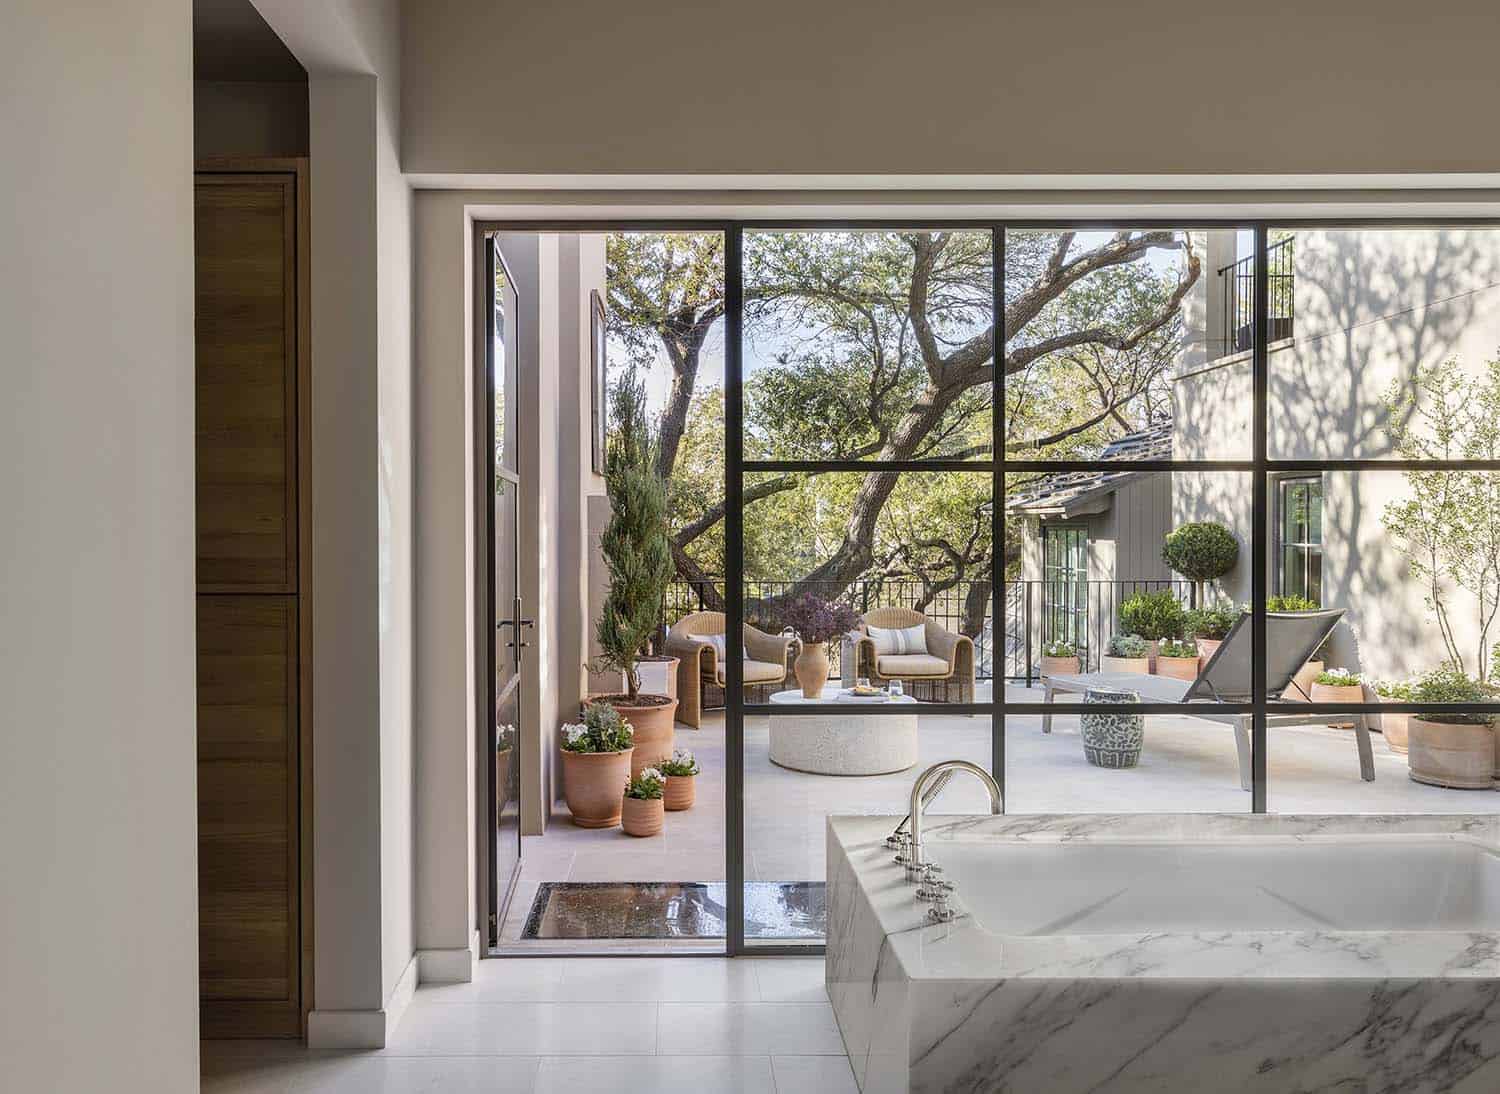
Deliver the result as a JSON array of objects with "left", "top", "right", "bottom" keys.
[{"left": 404, "top": 0, "right": 1500, "bottom": 176}]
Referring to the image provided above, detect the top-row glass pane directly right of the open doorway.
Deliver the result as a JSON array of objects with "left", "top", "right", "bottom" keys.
[{"left": 744, "top": 230, "right": 995, "bottom": 461}]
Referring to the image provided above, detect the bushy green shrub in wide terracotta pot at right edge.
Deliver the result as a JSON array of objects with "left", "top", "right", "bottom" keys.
[{"left": 1407, "top": 665, "right": 1497, "bottom": 789}]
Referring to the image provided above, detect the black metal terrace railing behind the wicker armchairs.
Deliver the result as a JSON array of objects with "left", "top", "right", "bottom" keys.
[{"left": 662, "top": 578, "right": 1193, "bottom": 684}]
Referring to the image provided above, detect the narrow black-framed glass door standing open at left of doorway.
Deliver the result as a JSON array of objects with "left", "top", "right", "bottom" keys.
[{"left": 476, "top": 239, "right": 533, "bottom": 945}]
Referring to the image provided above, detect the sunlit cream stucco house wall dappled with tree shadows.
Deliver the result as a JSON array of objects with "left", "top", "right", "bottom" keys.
[{"left": 1173, "top": 228, "right": 1500, "bottom": 675}]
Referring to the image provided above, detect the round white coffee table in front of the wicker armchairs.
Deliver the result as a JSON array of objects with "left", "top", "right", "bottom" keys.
[{"left": 771, "top": 684, "right": 917, "bottom": 774}]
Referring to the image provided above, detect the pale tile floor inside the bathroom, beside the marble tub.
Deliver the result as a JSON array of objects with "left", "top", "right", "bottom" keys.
[{"left": 203, "top": 957, "right": 855, "bottom": 1094}]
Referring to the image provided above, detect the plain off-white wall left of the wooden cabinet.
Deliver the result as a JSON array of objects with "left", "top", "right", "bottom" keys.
[{"left": 0, "top": 0, "right": 198, "bottom": 1094}]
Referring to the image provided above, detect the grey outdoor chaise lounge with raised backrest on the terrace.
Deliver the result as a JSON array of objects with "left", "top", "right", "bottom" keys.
[{"left": 1041, "top": 608, "right": 1376, "bottom": 791}]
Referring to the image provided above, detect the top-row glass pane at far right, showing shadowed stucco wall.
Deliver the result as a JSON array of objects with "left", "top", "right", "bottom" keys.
[{"left": 1272, "top": 227, "right": 1500, "bottom": 459}]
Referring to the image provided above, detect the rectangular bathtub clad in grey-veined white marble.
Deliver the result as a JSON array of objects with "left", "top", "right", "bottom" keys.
[{"left": 827, "top": 815, "right": 1500, "bottom": 1094}]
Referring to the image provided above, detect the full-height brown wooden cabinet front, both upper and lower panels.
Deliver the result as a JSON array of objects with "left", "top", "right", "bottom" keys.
[{"left": 195, "top": 165, "right": 312, "bottom": 1037}]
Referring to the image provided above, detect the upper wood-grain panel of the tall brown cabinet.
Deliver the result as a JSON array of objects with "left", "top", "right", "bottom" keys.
[{"left": 195, "top": 176, "right": 297, "bottom": 593}]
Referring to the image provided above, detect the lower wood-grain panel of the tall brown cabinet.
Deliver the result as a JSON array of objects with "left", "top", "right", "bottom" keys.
[{"left": 198, "top": 596, "right": 302, "bottom": 1032}]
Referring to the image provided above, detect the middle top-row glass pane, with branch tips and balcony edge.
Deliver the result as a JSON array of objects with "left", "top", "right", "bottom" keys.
[{"left": 1004, "top": 228, "right": 1251, "bottom": 461}]
